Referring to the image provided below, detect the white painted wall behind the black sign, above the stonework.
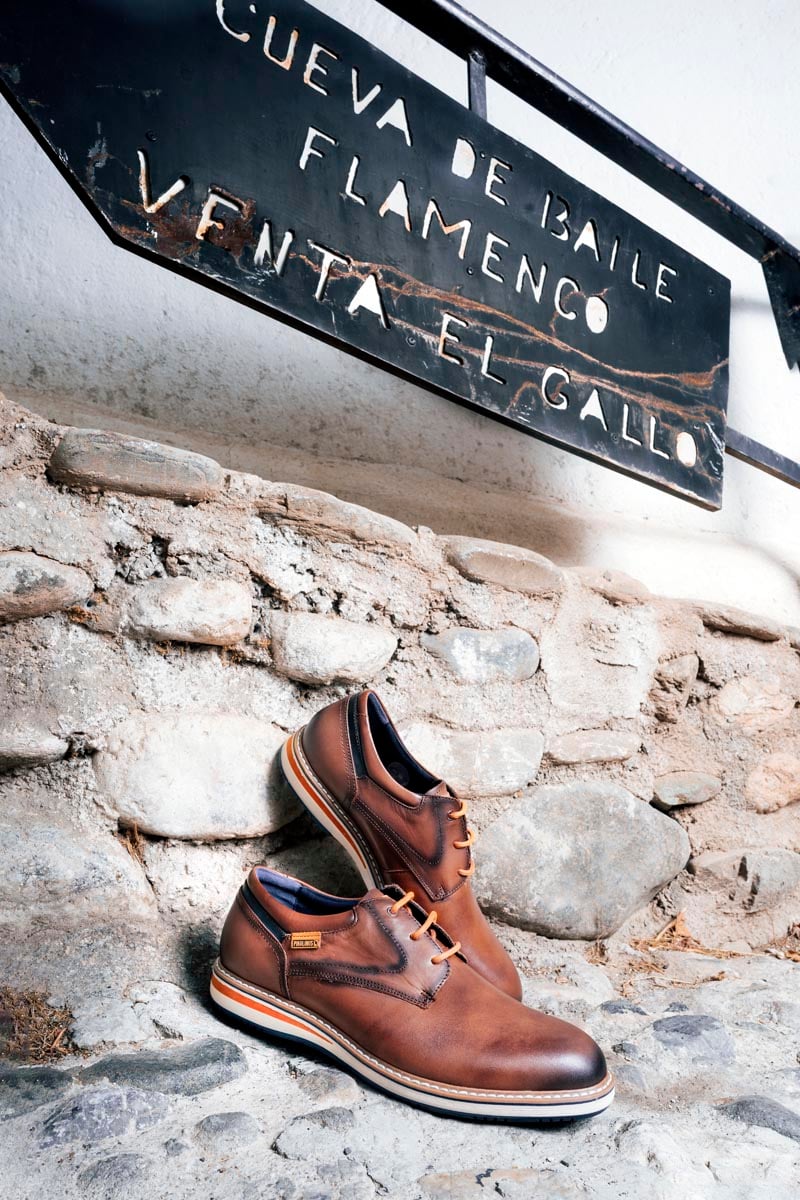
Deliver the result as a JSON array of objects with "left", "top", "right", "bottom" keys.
[{"left": 0, "top": 0, "right": 800, "bottom": 625}]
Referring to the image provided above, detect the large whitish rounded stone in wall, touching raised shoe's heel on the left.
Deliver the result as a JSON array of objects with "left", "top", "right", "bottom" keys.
[{"left": 92, "top": 712, "right": 299, "bottom": 840}]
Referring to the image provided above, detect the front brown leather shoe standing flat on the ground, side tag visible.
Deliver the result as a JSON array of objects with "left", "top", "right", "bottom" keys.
[{"left": 211, "top": 866, "right": 614, "bottom": 1122}]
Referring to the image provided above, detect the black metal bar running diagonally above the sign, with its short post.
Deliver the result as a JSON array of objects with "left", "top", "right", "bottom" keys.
[{"left": 379, "top": 0, "right": 800, "bottom": 367}]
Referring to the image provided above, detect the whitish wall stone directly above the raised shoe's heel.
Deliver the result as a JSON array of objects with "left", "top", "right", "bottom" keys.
[{"left": 271, "top": 612, "right": 397, "bottom": 684}]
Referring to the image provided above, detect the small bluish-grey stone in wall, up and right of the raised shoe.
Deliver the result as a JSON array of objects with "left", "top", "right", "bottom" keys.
[{"left": 421, "top": 628, "right": 539, "bottom": 683}]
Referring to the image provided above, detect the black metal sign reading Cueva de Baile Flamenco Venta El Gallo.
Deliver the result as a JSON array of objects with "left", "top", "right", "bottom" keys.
[{"left": 0, "top": 0, "right": 729, "bottom": 508}]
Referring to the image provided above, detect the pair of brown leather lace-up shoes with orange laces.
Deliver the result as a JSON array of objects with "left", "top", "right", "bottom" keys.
[{"left": 211, "top": 691, "right": 614, "bottom": 1121}]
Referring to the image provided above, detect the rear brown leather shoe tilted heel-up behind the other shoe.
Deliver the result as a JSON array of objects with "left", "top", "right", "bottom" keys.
[{"left": 281, "top": 691, "right": 522, "bottom": 1000}]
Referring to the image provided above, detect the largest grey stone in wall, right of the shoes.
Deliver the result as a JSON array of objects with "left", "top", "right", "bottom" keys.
[{"left": 476, "top": 781, "right": 690, "bottom": 940}]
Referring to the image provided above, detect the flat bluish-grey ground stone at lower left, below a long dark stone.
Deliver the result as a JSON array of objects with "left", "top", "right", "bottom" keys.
[{"left": 42, "top": 1087, "right": 172, "bottom": 1146}]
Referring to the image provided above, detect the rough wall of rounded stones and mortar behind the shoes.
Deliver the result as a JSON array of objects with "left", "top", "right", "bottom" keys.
[{"left": 0, "top": 388, "right": 800, "bottom": 1008}]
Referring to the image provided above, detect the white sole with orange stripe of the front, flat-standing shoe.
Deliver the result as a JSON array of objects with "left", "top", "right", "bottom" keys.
[{"left": 210, "top": 960, "right": 614, "bottom": 1123}]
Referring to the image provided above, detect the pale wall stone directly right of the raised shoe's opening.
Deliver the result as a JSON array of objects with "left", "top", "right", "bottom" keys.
[{"left": 398, "top": 721, "right": 545, "bottom": 796}]
